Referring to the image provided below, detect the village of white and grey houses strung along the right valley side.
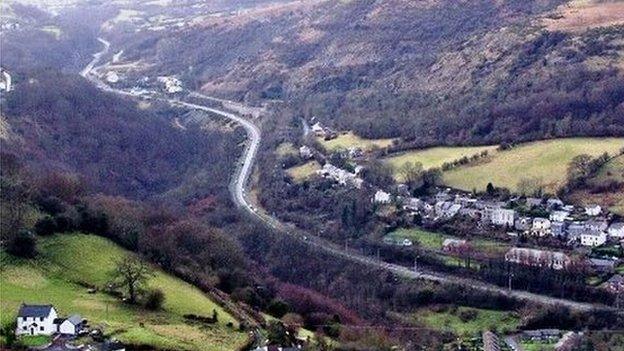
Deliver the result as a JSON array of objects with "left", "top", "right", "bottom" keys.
[{"left": 299, "top": 122, "right": 624, "bottom": 301}]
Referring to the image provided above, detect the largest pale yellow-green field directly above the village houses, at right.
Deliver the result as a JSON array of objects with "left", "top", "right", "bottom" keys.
[{"left": 444, "top": 138, "right": 624, "bottom": 192}]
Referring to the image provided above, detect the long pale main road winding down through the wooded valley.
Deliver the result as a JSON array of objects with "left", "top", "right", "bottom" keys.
[{"left": 80, "top": 38, "right": 612, "bottom": 311}]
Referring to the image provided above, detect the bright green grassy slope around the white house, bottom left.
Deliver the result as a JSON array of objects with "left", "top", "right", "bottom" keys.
[{"left": 0, "top": 234, "right": 246, "bottom": 350}]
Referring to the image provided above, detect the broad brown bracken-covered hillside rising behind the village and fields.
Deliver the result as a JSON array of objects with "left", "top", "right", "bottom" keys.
[{"left": 122, "top": 0, "right": 624, "bottom": 144}]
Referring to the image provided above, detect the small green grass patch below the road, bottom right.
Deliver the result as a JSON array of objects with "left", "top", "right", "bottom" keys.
[{"left": 413, "top": 306, "right": 520, "bottom": 336}]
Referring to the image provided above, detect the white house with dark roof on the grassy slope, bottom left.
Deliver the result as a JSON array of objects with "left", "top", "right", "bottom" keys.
[{"left": 15, "top": 304, "right": 58, "bottom": 335}]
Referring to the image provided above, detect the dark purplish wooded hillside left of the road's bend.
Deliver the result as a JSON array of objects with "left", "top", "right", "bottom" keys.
[{"left": 1, "top": 70, "right": 238, "bottom": 198}]
